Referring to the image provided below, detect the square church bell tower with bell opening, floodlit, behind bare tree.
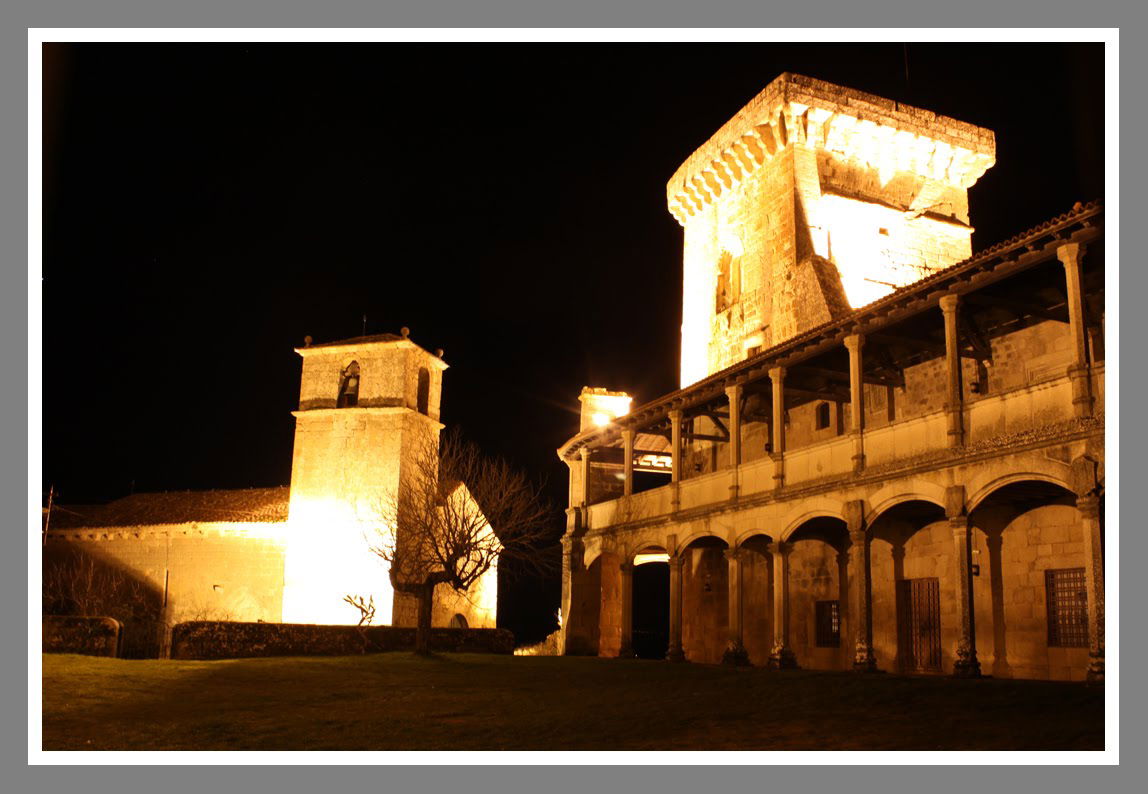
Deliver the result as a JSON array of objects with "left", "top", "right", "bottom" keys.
[{"left": 282, "top": 329, "right": 447, "bottom": 623}]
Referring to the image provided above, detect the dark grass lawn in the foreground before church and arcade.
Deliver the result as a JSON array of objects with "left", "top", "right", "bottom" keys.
[{"left": 44, "top": 653, "right": 1104, "bottom": 750}]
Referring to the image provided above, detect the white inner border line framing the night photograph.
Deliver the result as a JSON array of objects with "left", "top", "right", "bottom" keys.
[{"left": 28, "top": 28, "right": 1120, "bottom": 765}]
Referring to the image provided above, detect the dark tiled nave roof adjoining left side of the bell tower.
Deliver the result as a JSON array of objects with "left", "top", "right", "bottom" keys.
[{"left": 49, "top": 486, "right": 290, "bottom": 529}]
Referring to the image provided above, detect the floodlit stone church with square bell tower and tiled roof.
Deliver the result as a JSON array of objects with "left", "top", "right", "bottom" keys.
[{"left": 47, "top": 329, "right": 497, "bottom": 647}]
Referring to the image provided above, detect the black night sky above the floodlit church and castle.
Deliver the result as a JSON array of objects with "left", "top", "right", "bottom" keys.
[{"left": 42, "top": 44, "right": 1104, "bottom": 637}]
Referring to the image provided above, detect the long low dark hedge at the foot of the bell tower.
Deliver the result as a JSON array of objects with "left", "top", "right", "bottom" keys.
[{"left": 171, "top": 621, "right": 514, "bottom": 659}]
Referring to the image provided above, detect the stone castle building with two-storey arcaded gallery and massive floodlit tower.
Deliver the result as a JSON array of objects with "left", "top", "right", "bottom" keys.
[{"left": 558, "top": 75, "right": 1104, "bottom": 680}]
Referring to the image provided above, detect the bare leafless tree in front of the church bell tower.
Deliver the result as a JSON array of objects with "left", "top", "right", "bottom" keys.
[{"left": 369, "top": 433, "right": 553, "bottom": 654}]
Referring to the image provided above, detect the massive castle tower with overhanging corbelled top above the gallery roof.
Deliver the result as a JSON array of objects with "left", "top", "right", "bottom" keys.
[{"left": 666, "top": 73, "right": 995, "bottom": 387}]
